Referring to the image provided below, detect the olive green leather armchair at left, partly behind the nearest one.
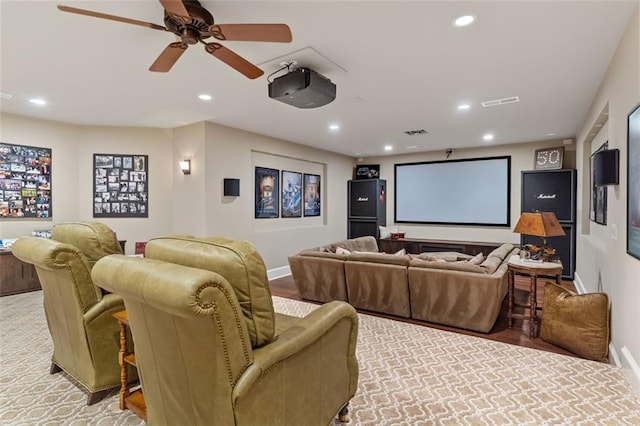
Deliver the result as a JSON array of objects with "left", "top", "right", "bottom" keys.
[{"left": 12, "top": 223, "right": 137, "bottom": 405}]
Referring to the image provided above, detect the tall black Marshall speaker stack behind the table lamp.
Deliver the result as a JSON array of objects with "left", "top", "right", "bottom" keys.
[{"left": 521, "top": 169, "right": 577, "bottom": 280}]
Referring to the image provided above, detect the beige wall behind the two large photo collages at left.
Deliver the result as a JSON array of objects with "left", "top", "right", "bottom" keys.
[{"left": 0, "top": 114, "right": 173, "bottom": 248}]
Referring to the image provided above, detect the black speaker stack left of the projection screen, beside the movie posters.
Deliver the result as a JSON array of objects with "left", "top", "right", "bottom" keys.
[{"left": 347, "top": 179, "right": 387, "bottom": 238}]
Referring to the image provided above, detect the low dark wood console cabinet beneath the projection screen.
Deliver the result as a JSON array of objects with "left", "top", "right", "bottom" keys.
[{"left": 378, "top": 238, "right": 502, "bottom": 256}]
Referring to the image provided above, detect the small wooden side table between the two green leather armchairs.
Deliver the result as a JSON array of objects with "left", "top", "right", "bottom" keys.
[{"left": 113, "top": 311, "right": 147, "bottom": 422}]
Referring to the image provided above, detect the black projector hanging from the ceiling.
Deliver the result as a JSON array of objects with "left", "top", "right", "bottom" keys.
[{"left": 269, "top": 68, "right": 336, "bottom": 108}]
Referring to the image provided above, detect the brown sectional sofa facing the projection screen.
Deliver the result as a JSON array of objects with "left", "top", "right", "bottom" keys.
[{"left": 289, "top": 237, "right": 518, "bottom": 333}]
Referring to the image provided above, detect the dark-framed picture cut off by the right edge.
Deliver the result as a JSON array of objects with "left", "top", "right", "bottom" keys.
[{"left": 627, "top": 105, "right": 640, "bottom": 259}]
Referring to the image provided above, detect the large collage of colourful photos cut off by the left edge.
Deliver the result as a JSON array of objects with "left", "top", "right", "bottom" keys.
[{"left": 0, "top": 142, "right": 52, "bottom": 219}]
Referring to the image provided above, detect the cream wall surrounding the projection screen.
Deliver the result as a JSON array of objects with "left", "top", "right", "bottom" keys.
[{"left": 362, "top": 140, "right": 575, "bottom": 244}]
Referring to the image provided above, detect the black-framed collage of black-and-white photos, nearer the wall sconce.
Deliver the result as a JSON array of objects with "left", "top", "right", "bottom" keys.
[{"left": 93, "top": 154, "right": 149, "bottom": 217}]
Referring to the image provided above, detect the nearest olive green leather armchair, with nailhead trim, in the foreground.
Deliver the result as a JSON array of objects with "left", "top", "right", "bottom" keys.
[{"left": 92, "top": 237, "right": 358, "bottom": 426}]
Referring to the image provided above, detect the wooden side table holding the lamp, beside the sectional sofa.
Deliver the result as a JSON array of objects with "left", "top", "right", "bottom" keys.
[{"left": 507, "top": 255, "right": 562, "bottom": 338}]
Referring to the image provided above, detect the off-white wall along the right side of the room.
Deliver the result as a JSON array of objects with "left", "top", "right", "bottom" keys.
[{"left": 576, "top": 7, "right": 640, "bottom": 395}]
